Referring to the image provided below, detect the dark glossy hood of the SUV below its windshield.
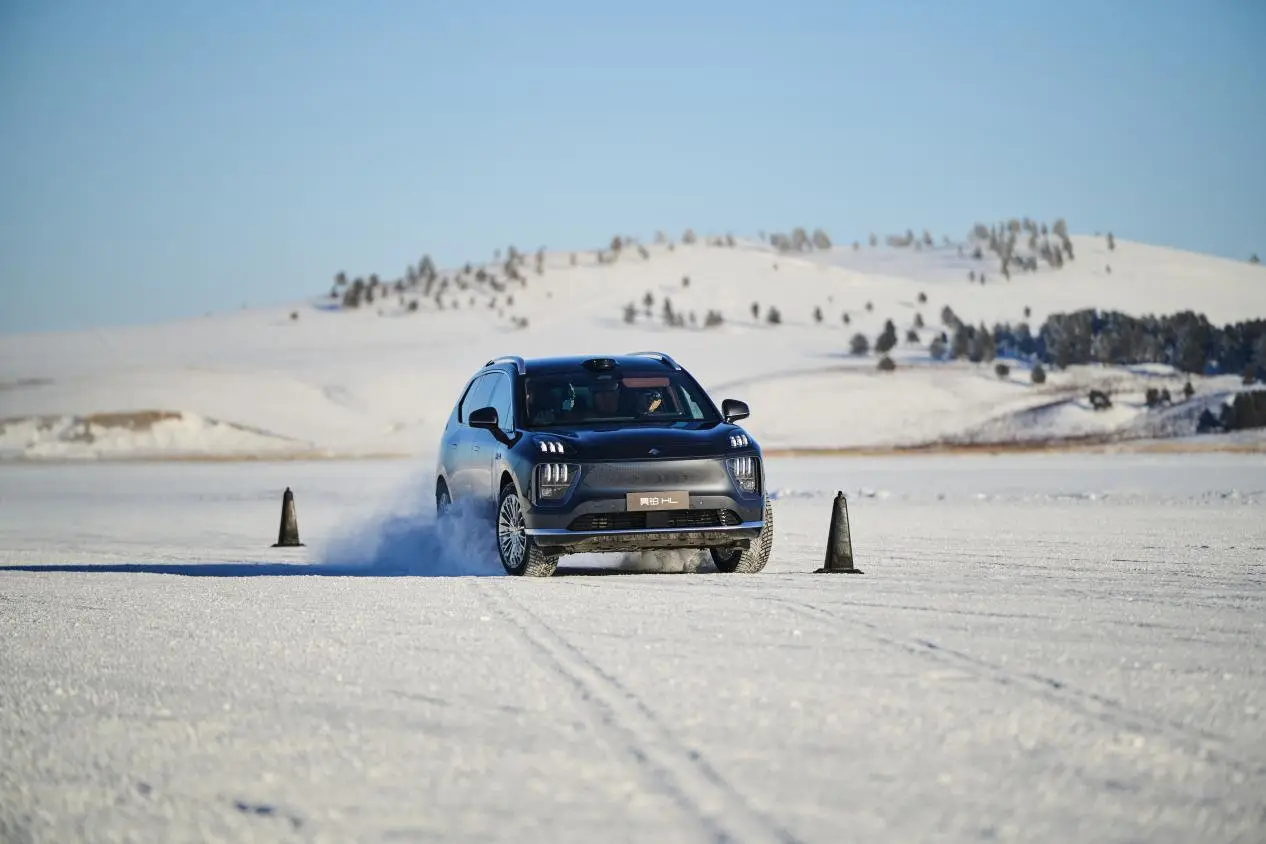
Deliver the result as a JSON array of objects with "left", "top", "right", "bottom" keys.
[{"left": 530, "top": 423, "right": 755, "bottom": 461}]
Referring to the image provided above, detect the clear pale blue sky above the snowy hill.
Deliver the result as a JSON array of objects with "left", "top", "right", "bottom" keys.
[{"left": 0, "top": 0, "right": 1266, "bottom": 332}]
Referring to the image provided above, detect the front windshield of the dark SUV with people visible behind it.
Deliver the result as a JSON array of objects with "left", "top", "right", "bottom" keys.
[{"left": 524, "top": 371, "right": 719, "bottom": 428}]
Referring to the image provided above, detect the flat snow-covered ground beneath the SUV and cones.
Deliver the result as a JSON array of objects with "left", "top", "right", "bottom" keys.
[{"left": 0, "top": 455, "right": 1266, "bottom": 844}]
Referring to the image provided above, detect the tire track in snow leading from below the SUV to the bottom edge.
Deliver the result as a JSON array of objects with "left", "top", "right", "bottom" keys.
[{"left": 477, "top": 582, "right": 800, "bottom": 844}]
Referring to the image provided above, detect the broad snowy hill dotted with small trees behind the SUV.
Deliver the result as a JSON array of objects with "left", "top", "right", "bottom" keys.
[{"left": 0, "top": 226, "right": 1266, "bottom": 459}]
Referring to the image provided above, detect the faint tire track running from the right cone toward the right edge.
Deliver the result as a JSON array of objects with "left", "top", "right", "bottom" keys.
[{"left": 762, "top": 596, "right": 1266, "bottom": 776}]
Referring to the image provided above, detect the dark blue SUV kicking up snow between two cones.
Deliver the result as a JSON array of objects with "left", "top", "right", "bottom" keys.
[{"left": 436, "top": 352, "right": 774, "bottom": 577}]
